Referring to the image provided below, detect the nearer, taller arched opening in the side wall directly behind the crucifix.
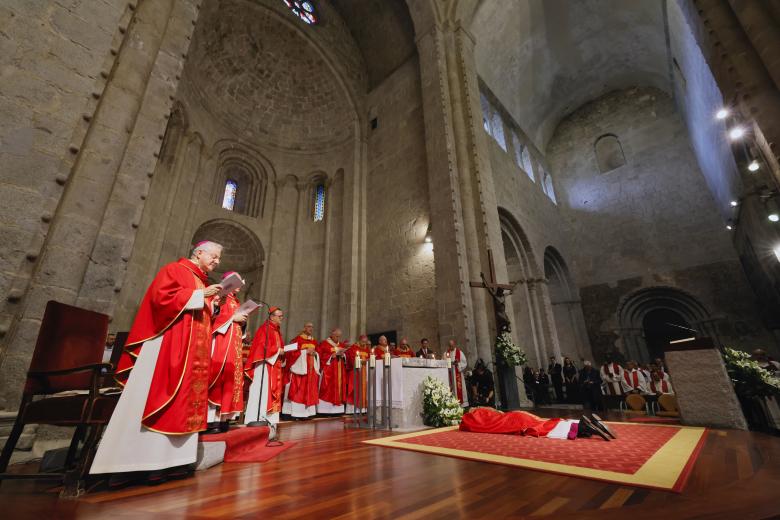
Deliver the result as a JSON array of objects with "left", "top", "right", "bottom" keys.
[{"left": 498, "top": 208, "right": 553, "bottom": 366}]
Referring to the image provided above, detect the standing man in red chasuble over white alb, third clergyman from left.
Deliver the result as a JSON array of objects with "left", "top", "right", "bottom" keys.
[{"left": 244, "top": 307, "right": 284, "bottom": 426}]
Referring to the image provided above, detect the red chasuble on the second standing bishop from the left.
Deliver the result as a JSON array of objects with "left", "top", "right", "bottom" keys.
[{"left": 209, "top": 294, "right": 244, "bottom": 414}]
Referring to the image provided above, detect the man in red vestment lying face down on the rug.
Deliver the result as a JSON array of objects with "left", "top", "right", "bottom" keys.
[{"left": 460, "top": 408, "right": 615, "bottom": 441}]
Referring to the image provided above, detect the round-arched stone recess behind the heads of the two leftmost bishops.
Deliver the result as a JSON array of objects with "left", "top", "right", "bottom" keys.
[{"left": 192, "top": 219, "right": 265, "bottom": 330}]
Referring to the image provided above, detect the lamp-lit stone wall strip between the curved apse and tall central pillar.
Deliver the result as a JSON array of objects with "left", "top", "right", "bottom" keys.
[{"left": 366, "top": 56, "right": 440, "bottom": 349}]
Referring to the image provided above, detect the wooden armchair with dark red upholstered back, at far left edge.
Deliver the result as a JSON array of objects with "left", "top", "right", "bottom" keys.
[{"left": 0, "top": 301, "right": 111, "bottom": 496}]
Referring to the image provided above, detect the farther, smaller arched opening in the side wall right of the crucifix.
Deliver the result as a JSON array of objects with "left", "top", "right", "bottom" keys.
[{"left": 544, "top": 246, "right": 590, "bottom": 363}]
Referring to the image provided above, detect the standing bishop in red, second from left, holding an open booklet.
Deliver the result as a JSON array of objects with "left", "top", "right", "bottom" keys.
[{"left": 207, "top": 271, "right": 247, "bottom": 433}]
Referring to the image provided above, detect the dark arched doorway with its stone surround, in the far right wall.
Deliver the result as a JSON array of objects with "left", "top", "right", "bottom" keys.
[{"left": 618, "top": 287, "right": 719, "bottom": 363}]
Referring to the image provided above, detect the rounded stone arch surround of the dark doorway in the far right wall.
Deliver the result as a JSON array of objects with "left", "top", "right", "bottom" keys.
[{"left": 617, "top": 286, "right": 719, "bottom": 363}]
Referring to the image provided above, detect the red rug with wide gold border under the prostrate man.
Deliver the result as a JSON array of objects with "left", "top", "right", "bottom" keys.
[{"left": 363, "top": 422, "right": 707, "bottom": 493}]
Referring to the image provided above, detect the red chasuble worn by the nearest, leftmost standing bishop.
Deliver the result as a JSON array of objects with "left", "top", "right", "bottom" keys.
[{"left": 116, "top": 258, "right": 211, "bottom": 434}]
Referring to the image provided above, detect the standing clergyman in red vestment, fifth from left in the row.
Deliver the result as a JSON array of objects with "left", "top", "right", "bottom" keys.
[{"left": 317, "top": 328, "right": 347, "bottom": 415}]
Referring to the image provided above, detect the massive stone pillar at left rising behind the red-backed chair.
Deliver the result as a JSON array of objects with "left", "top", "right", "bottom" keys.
[{"left": 0, "top": 0, "right": 197, "bottom": 408}]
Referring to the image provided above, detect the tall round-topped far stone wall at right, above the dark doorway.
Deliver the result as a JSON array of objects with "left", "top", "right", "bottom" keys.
[{"left": 548, "top": 89, "right": 771, "bottom": 357}]
